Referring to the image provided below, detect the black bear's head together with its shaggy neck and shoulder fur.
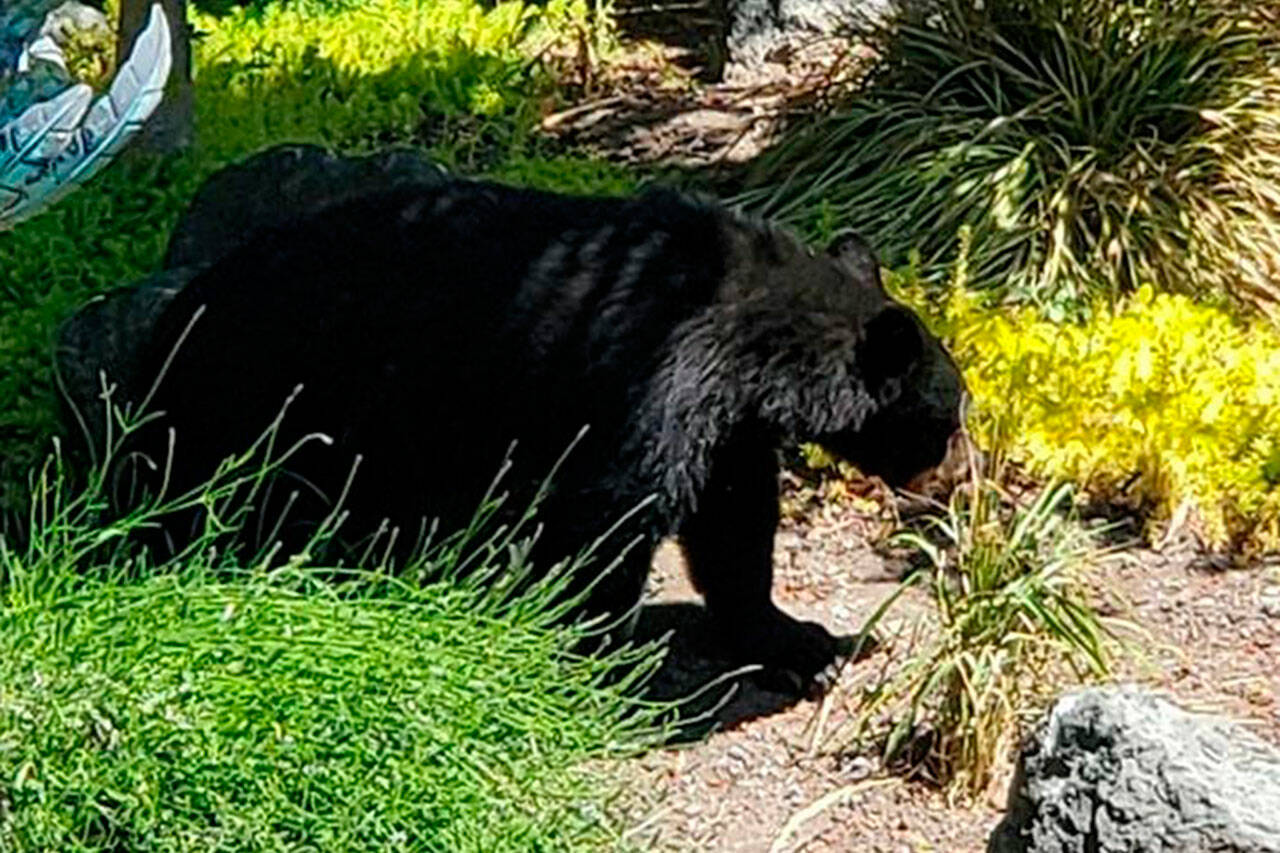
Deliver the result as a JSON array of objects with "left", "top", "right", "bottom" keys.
[{"left": 632, "top": 220, "right": 966, "bottom": 517}]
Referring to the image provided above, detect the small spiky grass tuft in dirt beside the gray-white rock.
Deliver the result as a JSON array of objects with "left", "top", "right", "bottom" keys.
[{"left": 855, "top": 475, "right": 1111, "bottom": 795}]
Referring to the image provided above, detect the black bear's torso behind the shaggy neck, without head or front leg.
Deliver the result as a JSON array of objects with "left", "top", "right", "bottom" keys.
[{"left": 136, "top": 181, "right": 733, "bottom": 512}]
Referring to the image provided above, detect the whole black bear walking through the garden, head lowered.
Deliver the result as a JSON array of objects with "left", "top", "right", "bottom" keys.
[{"left": 55, "top": 146, "right": 964, "bottom": 683}]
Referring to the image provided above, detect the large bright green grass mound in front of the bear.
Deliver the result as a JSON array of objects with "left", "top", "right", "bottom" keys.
[{"left": 0, "top": 435, "right": 666, "bottom": 852}]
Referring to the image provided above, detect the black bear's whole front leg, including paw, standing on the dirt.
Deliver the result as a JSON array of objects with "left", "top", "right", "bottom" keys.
[{"left": 680, "top": 441, "right": 851, "bottom": 690}]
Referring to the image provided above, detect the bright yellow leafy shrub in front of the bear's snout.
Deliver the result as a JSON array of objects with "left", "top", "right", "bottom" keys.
[{"left": 905, "top": 275, "right": 1280, "bottom": 547}]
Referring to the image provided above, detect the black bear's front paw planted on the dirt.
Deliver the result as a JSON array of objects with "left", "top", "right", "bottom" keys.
[{"left": 713, "top": 607, "right": 858, "bottom": 695}]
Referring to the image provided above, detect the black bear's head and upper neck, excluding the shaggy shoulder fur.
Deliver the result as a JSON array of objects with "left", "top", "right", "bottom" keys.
[{"left": 719, "top": 232, "right": 966, "bottom": 488}]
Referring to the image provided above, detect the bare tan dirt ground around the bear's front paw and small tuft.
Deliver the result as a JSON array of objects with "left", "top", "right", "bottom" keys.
[{"left": 624, "top": 484, "right": 1280, "bottom": 853}]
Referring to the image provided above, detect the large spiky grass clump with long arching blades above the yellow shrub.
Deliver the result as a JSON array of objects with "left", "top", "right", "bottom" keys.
[{"left": 737, "top": 0, "right": 1280, "bottom": 313}]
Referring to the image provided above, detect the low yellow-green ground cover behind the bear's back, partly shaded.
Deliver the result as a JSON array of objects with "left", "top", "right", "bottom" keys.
[{"left": 0, "top": 0, "right": 637, "bottom": 512}]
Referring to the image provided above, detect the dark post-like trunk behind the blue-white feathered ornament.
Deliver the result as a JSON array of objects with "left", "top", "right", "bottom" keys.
[{"left": 115, "top": 0, "right": 196, "bottom": 154}]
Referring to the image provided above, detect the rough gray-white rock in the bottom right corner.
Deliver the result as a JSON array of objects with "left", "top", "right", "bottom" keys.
[{"left": 987, "top": 688, "right": 1280, "bottom": 853}]
